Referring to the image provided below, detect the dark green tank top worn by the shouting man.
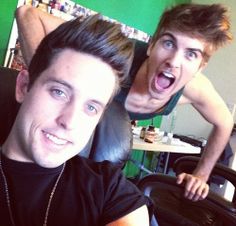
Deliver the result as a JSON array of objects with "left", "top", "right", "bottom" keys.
[{"left": 115, "top": 40, "right": 184, "bottom": 120}]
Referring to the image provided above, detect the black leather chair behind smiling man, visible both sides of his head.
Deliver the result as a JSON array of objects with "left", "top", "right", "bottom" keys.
[{"left": 0, "top": 67, "right": 132, "bottom": 167}]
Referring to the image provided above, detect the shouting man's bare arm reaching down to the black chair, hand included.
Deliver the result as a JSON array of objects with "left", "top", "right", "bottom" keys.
[{"left": 177, "top": 74, "right": 233, "bottom": 200}]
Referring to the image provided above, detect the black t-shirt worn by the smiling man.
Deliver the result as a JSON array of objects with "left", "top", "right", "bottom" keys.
[{"left": 0, "top": 156, "right": 148, "bottom": 226}]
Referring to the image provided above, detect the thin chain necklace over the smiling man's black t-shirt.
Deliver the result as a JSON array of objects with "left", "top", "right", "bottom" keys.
[{"left": 0, "top": 153, "right": 66, "bottom": 226}]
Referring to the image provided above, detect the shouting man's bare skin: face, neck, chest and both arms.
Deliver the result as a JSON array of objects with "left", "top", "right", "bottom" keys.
[{"left": 16, "top": 6, "right": 233, "bottom": 201}]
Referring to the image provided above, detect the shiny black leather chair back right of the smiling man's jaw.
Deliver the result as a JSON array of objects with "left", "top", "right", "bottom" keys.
[{"left": 89, "top": 101, "right": 132, "bottom": 165}]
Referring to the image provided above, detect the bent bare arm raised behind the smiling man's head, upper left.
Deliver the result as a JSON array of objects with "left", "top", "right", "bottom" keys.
[{"left": 16, "top": 5, "right": 64, "bottom": 65}]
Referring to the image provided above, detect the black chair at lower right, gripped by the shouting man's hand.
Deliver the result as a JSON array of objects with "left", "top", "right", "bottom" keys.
[{"left": 138, "top": 156, "right": 236, "bottom": 226}]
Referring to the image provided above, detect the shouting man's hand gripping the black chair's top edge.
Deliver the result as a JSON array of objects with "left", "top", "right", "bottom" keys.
[{"left": 176, "top": 173, "right": 209, "bottom": 201}]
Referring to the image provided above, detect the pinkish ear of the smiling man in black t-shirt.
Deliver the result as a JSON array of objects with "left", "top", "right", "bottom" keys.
[{"left": 15, "top": 70, "right": 29, "bottom": 103}]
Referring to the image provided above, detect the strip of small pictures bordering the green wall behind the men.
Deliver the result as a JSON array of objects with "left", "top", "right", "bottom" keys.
[{"left": 7, "top": 0, "right": 150, "bottom": 70}]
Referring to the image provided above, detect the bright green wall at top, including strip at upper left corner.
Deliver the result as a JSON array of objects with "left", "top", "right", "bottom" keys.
[{"left": 0, "top": 0, "right": 191, "bottom": 65}]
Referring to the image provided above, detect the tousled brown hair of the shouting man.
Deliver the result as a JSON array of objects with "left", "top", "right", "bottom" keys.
[{"left": 152, "top": 4, "right": 232, "bottom": 61}]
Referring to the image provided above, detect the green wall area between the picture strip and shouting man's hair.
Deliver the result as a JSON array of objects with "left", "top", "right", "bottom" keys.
[{"left": 75, "top": 0, "right": 190, "bottom": 34}]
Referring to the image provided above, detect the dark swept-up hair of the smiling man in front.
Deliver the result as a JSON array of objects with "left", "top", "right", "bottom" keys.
[{"left": 29, "top": 14, "right": 133, "bottom": 93}]
